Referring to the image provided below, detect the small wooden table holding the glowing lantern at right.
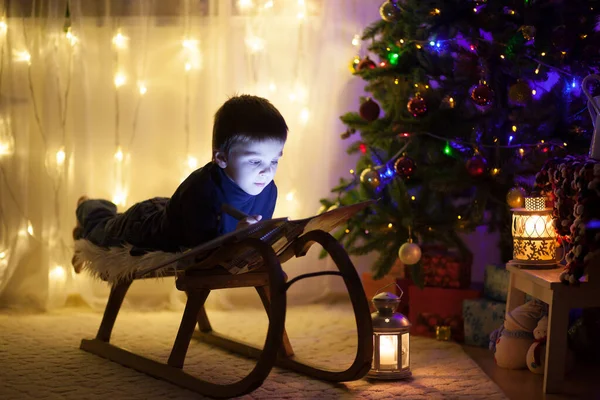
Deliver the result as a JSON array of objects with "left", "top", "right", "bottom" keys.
[{"left": 506, "top": 258, "right": 600, "bottom": 393}]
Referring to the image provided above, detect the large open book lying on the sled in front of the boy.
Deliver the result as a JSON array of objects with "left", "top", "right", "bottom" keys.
[{"left": 137, "top": 201, "right": 373, "bottom": 277}]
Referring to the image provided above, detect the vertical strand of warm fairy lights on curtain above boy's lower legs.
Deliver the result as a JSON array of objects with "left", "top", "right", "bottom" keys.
[{"left": 107, "top": 12, "right": 129, "bottom": 207}]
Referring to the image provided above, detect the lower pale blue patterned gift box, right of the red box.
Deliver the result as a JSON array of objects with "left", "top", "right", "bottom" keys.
[{"left": 463, "top": 298, "right": 506, "bottom": 347}]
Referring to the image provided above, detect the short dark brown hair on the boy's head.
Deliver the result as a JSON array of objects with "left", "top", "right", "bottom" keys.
[{"left": 213, "top": 94, "right": 288, "bottom": 153}]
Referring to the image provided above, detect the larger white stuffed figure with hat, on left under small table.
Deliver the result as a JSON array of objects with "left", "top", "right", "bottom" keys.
[{"left": 490, "top": 299, "right": 547, "bottom": 369}]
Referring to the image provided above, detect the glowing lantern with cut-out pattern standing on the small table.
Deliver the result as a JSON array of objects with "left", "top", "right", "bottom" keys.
[{"left": 510, "top": 197, "right": 556, "bottom": 268}]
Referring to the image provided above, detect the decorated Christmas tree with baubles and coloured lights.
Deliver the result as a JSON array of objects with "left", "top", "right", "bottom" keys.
[{"left": 321, "top": 0, "right": 600, "bottom": 283}]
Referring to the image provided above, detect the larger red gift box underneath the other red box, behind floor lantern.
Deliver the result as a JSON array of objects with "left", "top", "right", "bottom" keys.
[{"left": 408, "top": 286, "right": 481, "bottom": 342}]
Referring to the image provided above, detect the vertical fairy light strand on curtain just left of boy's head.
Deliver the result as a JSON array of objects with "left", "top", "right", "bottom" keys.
[{"left": 181, "top": 0, "right": 202, "bottom": 182}]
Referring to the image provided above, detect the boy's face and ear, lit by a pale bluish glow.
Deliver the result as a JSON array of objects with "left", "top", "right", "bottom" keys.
[{"left": 215, "top": 140, "right": 285, "bottom": 196}]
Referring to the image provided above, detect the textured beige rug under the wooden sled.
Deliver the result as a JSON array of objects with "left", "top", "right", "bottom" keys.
[{"left": 0, "top": 304, "right": 506, "bottom": 400}]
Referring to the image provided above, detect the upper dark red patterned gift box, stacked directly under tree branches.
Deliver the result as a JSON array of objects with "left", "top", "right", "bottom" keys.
[{"left": 421, "top": 246, "right": 473, "bottom": 288}]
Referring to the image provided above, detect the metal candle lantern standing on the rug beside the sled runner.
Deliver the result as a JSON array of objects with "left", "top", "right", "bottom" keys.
[{"left": 367, "top": 284, "right": 412, "bottom": 379}]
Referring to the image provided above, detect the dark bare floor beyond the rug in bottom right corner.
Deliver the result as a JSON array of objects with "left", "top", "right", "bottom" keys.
[{"left": 463, "top": 346, "right": 600, "bottom": 400}]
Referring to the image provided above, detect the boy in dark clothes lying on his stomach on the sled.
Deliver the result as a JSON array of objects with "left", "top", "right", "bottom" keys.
[{"left": 73, "top": 95, "right": 288, "bottom": 273}]
